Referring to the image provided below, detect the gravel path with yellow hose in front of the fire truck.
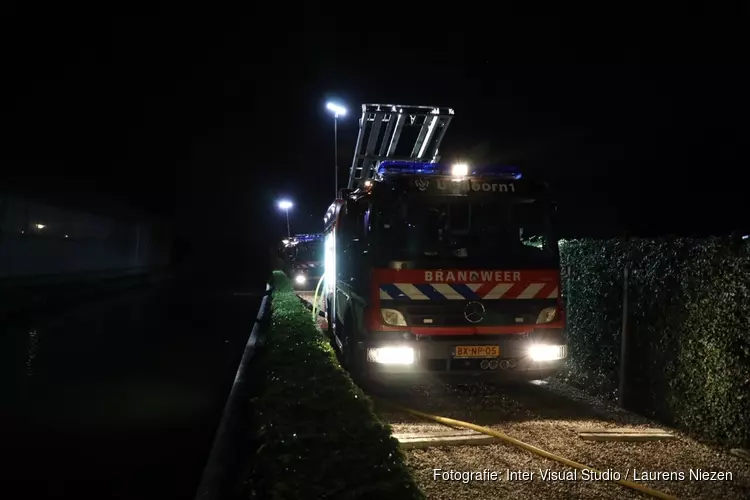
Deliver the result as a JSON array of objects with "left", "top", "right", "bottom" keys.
[{"left": 376, "top": 381, "right": 750, "bottom": 500}]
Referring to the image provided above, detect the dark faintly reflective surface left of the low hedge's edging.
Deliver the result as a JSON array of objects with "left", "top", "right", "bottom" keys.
[{"left": 0, "top": 284, "right": 263, "bottom": 500}]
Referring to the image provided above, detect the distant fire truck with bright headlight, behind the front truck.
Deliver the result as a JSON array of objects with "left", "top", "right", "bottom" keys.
[{"left": 282, "top": 233, "right": 323, "bottom": 290}]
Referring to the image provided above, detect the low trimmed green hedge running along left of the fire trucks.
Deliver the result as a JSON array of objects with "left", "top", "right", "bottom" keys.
[{"left": 245, "top": 271, "right": 424, "bottom": 500}]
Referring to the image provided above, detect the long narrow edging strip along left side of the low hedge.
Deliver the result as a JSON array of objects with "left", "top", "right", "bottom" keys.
[{"left": 195, "top": 284, "right": 273, "bottom": 500}]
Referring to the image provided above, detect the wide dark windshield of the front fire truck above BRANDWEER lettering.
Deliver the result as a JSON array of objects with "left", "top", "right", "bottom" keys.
[{"left": 375, "top": 197, "right": 557, "bottom": 267}]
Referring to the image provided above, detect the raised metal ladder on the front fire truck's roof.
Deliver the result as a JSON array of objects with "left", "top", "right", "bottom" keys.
[{"left": 348, "top": 104, "right": 453, "bottom": 189}]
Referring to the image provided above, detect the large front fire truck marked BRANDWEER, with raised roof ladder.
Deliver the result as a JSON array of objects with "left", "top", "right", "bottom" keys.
[{"left": 324, "top": 104, "right": 567, "bottom": 382}]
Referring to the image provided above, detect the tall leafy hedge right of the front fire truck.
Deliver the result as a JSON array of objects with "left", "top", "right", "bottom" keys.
[{"left": 561, "top": 238, "right": 750, "bottom": 447}]
